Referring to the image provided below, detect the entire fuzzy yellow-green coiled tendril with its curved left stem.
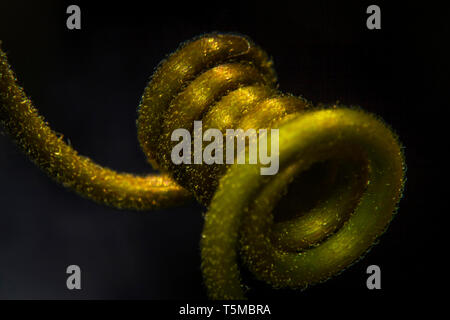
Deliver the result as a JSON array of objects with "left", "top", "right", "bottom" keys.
[{"left": 0, "top": 34, "right": 405, "bottom": 299}]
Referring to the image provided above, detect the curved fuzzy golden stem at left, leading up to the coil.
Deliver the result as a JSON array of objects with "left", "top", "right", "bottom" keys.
[{"left": 0, "top": 45, "right": 192, "bottom": 210}]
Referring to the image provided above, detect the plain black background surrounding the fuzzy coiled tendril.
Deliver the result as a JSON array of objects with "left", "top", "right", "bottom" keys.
[{"left": 0, "top": 1, "right": 448, "bottom": 304}]
